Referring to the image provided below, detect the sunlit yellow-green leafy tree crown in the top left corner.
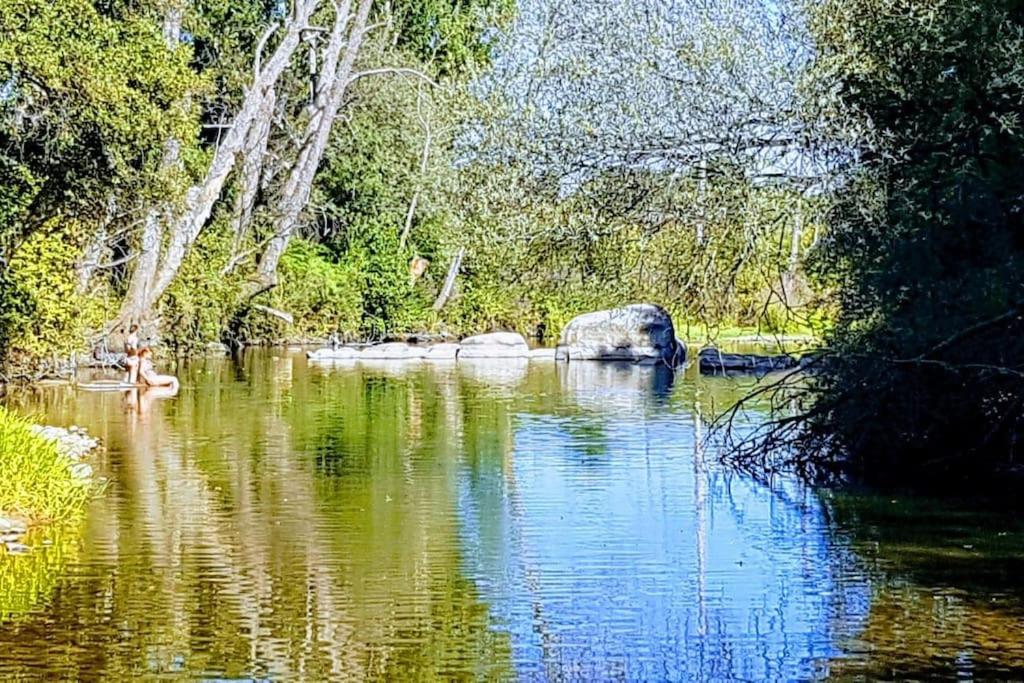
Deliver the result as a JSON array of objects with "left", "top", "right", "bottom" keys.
[{"left": 0, "top": 0, "right": 199, "bottom": 262}]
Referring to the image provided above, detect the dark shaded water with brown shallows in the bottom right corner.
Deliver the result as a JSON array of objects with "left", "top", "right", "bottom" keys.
[{"left": 826, "top": 494, "right": 1024, "bottom": 680}]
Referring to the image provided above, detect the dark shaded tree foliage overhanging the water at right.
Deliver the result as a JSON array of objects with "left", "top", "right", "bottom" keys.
[{"left": 774, "top": 0, "right": 1024, "bottom": 484}]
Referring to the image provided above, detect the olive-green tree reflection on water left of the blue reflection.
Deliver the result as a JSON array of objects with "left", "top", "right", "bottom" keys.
[{"left": 0, "top": 357, "right": 511, "bottom": 680}]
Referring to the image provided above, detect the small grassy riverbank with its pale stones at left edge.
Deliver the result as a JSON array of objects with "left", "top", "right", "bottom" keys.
[{"left": 0, "top": 408, "right": 99, "bottom": 552}]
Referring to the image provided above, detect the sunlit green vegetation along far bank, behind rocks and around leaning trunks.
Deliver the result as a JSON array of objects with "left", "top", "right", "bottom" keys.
[{"left": 0, "top": 0, "right": 821, "bottom": 368}]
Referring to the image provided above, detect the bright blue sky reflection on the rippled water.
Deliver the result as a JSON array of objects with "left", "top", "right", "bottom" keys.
[{"left": 459, "top": 374, "right": 870, "bottom": 680}]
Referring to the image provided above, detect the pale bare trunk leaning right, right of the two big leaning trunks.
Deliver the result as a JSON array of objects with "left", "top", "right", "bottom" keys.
[{"left": 248, "top": 0, "right": 373, "bottom": 296}]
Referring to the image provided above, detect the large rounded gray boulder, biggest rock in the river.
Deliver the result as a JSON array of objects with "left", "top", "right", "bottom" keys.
[{"left": 556, "top": 303, "right": 686, "bottom": 367}]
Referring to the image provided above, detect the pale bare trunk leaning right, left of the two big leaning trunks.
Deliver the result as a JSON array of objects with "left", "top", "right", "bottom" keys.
[{"left": 122, "top": 0, "right": 319, "bottom": 316}]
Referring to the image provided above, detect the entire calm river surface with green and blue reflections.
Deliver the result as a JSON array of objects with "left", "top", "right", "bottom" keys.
[{"left": 0, "top": 350, "right": 1024, "bottom": 681}]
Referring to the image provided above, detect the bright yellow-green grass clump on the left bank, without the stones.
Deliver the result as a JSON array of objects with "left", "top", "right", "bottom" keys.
[{"left": 0, "top": 408, "right": 91, "bottom": 522}]
